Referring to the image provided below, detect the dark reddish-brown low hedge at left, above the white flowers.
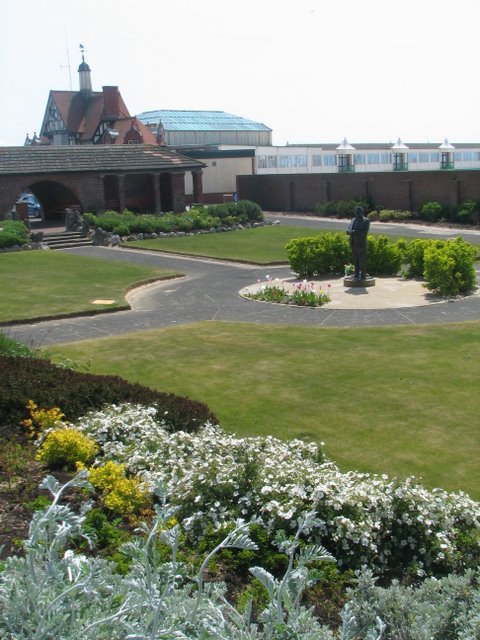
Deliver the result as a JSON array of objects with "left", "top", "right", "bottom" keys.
[{"left": 0, "top": 356, "right": 218, "bottom": 433}]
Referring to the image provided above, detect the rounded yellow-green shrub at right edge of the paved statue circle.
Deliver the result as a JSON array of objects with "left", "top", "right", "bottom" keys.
[{"left": 424, "top": 238, "right": 477, "bottom": 296}]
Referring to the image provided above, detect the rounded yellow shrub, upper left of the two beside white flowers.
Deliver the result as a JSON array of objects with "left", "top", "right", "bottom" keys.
[{"left": 37, "top": 427, "right": 98, "bottom": 470}]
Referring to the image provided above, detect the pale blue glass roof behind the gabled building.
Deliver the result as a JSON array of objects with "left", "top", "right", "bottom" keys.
[{"left": 137, "top": 109, "right": 271, "bottom": 131}]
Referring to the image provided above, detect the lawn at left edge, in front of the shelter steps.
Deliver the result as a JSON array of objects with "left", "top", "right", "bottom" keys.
[{"left": 0, "top": 251, "right": 178, "bottom": 322}]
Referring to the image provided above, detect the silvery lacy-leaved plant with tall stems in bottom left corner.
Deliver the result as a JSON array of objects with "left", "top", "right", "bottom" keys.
[{"left": 0, "top": 471, "right": 381, "bottom": 640}]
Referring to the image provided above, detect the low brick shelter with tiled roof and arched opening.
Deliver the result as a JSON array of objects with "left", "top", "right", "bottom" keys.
[{"left": 0, "top": 144, "right": 205, "bottom": 222}]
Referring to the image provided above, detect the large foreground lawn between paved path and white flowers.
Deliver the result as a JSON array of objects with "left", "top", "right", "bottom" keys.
[{"left": 47, "top": 322, "right": 480, "bottom": 499}]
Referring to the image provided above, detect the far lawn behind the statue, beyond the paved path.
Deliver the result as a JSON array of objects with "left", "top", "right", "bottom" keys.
[{"left": 124, "top": 224, "right": 320, "bottom": 264}]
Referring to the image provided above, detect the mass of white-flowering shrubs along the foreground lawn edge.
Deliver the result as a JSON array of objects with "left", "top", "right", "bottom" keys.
[{"left": 71, "top": 405, "right": 480, "bottom": 576}]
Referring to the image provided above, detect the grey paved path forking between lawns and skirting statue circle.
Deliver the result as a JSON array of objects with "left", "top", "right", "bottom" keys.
[{"left": 3, "top": 217, "right": 480, "bottom": 347}]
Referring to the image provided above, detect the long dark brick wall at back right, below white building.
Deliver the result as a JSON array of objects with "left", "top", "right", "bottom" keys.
[{"left": 237, "top": 171, "right": 480, "bottom": 211}]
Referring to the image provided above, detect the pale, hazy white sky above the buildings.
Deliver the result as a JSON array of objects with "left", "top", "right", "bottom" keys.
[{"left": 0, "top": 0, "right": 480, "bottom": 145}]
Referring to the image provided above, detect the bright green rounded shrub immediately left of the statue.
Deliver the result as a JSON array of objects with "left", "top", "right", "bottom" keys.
[{"left": 285, "top": 232, "right": 351, "bottom": 277}]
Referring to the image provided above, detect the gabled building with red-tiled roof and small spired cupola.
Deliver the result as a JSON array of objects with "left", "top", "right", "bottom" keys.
[{"left": 31, "top": 54, "right": 157, "bottom": 146}]
